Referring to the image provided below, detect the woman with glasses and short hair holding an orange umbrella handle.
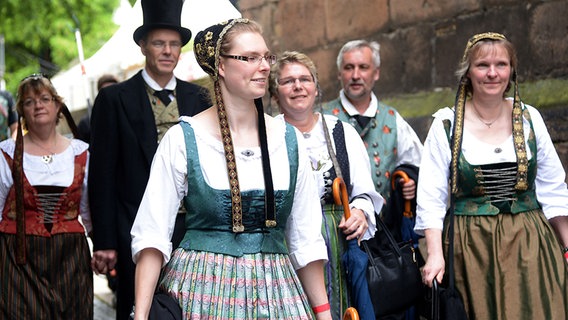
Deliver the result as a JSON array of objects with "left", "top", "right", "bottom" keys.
[{"left": 269, "top": 51, "right": 383, "bottom": 319}]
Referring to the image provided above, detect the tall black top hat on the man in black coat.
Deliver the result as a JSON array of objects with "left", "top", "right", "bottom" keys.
[{"left": 133, "top": 0, "right": 191, "bottom": 45}]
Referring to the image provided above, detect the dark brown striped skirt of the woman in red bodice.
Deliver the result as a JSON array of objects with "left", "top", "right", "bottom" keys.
[{"left": 0, "top": 233, "right": 93, "bottom": 320}]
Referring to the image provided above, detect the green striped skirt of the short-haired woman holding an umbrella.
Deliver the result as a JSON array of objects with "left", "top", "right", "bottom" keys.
[{"left": 322, "top": 205, "right": 349, "bottom": 320}]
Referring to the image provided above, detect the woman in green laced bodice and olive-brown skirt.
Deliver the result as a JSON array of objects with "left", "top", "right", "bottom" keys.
[{"left": 415, "top": 32, "right": 568, "bottom": 320}]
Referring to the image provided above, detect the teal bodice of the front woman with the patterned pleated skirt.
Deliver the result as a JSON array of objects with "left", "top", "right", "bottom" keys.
[{"left": 180, "top": 121, "right": 298, "bottom": 256}]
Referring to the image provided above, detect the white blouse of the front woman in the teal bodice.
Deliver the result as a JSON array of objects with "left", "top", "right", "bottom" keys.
[{"left": 131, "top": 115, "right": 327, "bottom": 269}]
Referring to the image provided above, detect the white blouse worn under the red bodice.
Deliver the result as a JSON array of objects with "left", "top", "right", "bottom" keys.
[{"left": 0, "top": 139, "right": 92, "bottom": 232}]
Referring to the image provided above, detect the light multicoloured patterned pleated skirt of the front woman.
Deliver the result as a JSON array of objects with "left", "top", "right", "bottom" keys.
[{"left": 159, "top": 248, "right": 313, "bottom": 320}]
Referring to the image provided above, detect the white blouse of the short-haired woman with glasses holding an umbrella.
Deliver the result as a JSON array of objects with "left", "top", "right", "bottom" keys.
[{"left": 276, "top": 113, "right": 384, "bottom": 240}]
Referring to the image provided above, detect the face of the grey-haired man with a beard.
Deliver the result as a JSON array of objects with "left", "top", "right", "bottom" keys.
[{"left": 338, "top": 47, "right": 379, "bottom": 105}]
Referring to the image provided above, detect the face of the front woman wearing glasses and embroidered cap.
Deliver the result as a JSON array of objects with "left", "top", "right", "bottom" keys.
[{"left": 219, "top": 32, "right": 270, "bottom": 100}]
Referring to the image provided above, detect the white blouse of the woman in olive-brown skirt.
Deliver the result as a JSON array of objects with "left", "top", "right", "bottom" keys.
[{"left": 414, "top": 105, "right": 568, "bottom": 234}]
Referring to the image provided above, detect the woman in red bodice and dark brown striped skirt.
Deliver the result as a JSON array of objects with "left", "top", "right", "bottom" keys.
[{"left": 0, "top": 75, "right": 93, "bottom": 319}]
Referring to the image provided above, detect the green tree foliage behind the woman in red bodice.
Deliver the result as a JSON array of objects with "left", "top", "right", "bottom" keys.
[{"left": 0, "top": 0, "right": 120, "bottom": 93}]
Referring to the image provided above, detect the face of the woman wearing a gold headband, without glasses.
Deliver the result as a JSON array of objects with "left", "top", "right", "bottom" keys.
[{"left": 467, "top": 42, "right": 511, "bottom": 97}]
